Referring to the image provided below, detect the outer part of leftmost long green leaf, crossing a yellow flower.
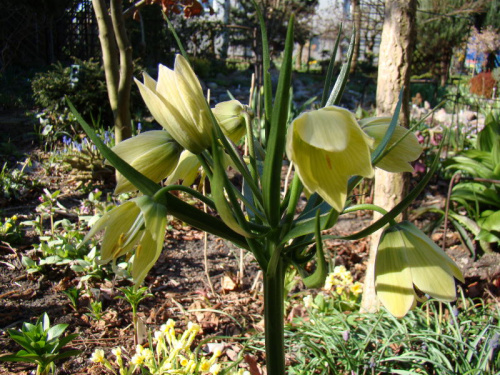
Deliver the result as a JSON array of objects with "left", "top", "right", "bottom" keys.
[{"left": 66, "top": 98, "right": 160, "bottom": 196}]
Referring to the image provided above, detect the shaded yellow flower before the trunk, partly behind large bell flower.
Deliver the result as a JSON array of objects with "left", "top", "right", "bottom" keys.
[{"left": 359, "top": 117, "right": 423, "bottom": 173}]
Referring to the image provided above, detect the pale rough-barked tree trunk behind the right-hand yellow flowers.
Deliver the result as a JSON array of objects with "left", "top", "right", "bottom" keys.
[{"left": 361, "top": 0, "right": 417, "bottom": 312}]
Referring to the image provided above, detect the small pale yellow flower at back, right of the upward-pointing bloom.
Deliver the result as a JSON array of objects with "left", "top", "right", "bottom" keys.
[{"left": 212, "top": 100, "right": 247, "bottom": 143}]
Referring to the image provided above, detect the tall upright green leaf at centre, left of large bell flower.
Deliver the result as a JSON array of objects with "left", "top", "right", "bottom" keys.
[{"left": 262, "top": 15, "right": 295, "bottom": 226}]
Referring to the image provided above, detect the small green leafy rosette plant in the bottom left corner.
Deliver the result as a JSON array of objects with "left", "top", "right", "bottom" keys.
[{"left": 0, "top": 313, "right": 80, "bottom": 375}]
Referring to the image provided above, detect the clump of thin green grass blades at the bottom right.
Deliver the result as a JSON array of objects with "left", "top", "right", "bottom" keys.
[{"left": 287, "top": 296, "right": 500, "bottom": 375}]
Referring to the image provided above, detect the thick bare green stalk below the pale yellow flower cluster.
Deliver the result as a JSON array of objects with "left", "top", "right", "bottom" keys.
[{"left": 264, "top": 259, "right": 286, "bottom": 375}]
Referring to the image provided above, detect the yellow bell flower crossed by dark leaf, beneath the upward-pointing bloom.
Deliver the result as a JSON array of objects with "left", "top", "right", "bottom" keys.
[{"left": 112, "top": 130, "right": 182, "bottom": 194}]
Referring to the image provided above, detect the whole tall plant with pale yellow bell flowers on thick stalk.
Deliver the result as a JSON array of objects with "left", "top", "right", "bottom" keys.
[{"left": 70, "top": 7, "right": 462, "bottom": 375}]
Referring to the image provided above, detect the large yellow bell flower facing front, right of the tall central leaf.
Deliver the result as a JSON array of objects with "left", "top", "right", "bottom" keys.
[{"left": 286, "top": 106, "right": 373, "bottom": 211}]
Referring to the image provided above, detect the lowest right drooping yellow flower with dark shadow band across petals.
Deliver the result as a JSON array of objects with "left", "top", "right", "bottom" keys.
[{"left": 375, "top": 221, "right": 464, "bottom": 318}]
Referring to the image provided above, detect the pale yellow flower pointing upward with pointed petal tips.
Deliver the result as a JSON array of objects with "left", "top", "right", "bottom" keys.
[{"left": 135, "top": 55, "right": 212, "bottom": 154}]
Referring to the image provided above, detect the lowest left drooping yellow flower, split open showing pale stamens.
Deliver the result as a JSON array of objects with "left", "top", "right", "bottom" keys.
[{"left": 83, "top": 196, "right": 167, "bottom": 284}]
